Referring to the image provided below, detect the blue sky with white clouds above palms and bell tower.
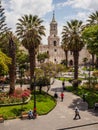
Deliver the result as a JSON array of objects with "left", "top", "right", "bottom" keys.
[{"left": 1, "top": 0, "right": 98, "bottom": 44}]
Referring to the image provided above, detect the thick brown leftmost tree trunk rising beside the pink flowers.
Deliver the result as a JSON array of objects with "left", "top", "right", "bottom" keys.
[{"left": 9, "top": 38, "right": 16, "bottom": 94}]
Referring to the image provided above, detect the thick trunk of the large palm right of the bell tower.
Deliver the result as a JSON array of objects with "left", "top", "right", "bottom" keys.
[{"left": 73, "top": 51, "right": 79, "bottom": 79}]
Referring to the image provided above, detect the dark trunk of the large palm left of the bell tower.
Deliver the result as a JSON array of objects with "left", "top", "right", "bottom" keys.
[{"left": 29, "top": 49, "right": 35, "bottom": 90}]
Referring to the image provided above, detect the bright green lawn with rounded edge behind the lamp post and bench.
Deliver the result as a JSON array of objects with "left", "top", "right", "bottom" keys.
[{"left": 0, "top": 92, "right": 56, "bottom": 119}]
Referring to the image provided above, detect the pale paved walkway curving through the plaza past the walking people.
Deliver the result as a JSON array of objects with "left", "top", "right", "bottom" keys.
[{"left": 0, "top": 80, "right": 98, "bottom": 130}]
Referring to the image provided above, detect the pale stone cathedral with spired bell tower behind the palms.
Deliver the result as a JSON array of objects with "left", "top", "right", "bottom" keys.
[{"left": 39, "top": 13, "right": 90, "bottom": 65}]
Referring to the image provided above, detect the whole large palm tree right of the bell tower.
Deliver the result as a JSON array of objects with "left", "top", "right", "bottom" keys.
[{"left": 63, "top": 20, "right": 84, "bottom": 79}]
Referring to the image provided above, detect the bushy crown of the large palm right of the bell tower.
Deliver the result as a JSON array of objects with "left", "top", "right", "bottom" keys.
[{"left": 62, "top": 20, "right": 84, "bottom": 51}]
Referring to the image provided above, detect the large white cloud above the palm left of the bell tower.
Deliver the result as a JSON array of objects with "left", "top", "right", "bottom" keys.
[{"left": 2, "top": 0, "right": 53, "bottom": 31}]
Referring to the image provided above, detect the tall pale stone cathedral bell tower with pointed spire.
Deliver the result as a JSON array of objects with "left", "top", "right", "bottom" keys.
[{"left": 48, "top": 12, "right": 60, "bottom": 64}]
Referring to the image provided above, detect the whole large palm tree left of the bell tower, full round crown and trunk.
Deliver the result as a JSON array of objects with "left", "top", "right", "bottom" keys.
[{"left": 16, "top": 14, "right": 45, "bottom": 89}]
